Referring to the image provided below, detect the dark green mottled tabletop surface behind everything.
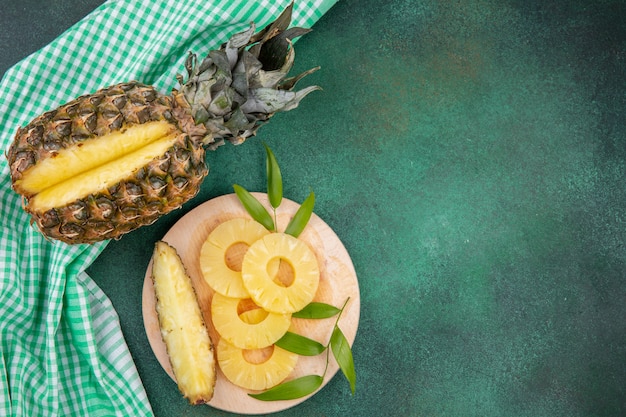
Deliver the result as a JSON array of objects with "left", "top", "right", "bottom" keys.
[{"left": 0, "top": 0, "right": 626, "bottom": 417}]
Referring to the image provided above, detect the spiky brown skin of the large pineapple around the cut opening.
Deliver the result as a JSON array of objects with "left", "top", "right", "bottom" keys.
[{"left": 7, "top": 82, "right": 208, "bottom": 244}]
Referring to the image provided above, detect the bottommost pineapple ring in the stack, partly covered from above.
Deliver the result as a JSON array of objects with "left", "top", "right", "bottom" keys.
[{"left": 217, "top": 338, "right": 298, "bottom": 390}]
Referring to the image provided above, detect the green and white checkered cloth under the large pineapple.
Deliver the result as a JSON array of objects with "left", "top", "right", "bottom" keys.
[{"left": 0, "top": 0, "right": 336, "bottom": 417}]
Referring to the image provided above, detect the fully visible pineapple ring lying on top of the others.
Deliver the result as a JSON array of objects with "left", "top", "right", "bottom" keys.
[{"left": 241, "top": 233, "right": 320, "bottom": 314}]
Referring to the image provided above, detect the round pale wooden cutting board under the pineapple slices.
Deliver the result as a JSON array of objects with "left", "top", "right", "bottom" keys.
[{"left": 142, "top": 193, "right": 360, "bottom": 414}]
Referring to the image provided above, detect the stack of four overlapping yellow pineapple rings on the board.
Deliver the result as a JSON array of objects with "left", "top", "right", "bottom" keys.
[{"left": 200, "top": 218, "right": 320, "bottom": 390}]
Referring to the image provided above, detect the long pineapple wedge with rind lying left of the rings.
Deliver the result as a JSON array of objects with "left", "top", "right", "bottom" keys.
[{"left": 152, "top": 241, "right": 216, "bottom": 404}]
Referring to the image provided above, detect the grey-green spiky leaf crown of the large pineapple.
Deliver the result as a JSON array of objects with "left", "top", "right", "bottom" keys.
[{"left": 176, "top": 3, "right": 320, "bottom": 149}]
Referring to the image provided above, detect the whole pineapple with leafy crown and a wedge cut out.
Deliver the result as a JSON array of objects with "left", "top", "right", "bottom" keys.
[{"left": 7, "top": 5, "right": 318, "bottom": 244}]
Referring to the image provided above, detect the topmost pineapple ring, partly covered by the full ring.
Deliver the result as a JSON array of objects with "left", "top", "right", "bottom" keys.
[{"left": 200, "top": 218, "right": 269, "bottom": 298}]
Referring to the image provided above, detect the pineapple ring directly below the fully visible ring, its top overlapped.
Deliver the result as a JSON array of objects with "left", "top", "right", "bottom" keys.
[{"left": 211, "top": 293, "right": 291, "bottom": 349}]
